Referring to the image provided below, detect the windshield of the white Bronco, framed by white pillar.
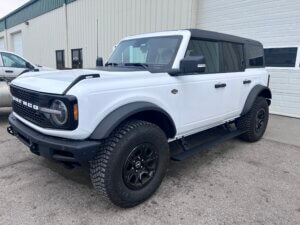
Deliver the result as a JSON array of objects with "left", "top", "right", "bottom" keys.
[{"left": 106, "top": 36, "right": 182, "bottom": 69}]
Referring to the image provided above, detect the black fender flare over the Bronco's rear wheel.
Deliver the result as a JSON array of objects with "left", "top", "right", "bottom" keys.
[{"left": 241, "top": 84, "right": 272, "bottom": 116}]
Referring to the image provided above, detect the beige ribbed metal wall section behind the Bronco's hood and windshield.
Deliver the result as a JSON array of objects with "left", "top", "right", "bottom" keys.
[{"left": 67, "top": 0, "right": 195, "bottom": 67}]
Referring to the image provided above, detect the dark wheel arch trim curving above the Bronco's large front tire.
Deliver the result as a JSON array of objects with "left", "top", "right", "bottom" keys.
[{"left": 89, "top": 102, "right": 177, "bottom": 140}]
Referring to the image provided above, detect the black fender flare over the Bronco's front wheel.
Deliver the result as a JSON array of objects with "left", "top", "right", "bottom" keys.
[{"left": 89, "top": 102, "right": 176, "bottom": 140}]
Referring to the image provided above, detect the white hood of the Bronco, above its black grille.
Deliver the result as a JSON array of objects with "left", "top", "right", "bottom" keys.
[{"left": 11, "top": 70, "right": 99, "bottom": 94}]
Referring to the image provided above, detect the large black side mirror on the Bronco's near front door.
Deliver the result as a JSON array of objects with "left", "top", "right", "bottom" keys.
[{"left": 179, "top": 56, "right": 206, "bottom": 73}]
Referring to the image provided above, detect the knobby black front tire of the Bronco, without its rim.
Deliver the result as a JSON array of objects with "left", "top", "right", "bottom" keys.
[{"left": 90, "top": 120, "right": 169, "bottom": 208}]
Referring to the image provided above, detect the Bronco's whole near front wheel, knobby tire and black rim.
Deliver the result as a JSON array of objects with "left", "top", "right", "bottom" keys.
[{"left": 90, "top": 120, "right": 169, "bottom": 208}]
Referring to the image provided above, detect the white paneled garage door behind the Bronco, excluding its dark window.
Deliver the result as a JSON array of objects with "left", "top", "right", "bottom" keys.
[{"left": 196, "top": 0, "right": 300, "bottom": 118}]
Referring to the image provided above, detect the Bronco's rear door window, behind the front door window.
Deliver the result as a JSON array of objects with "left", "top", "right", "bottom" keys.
[{"left": 222, "top": 42, "right": 244, "bottom": 72}]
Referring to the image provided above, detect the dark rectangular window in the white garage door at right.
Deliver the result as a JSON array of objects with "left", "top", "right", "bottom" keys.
[{"left": 265, "top": 48, "right": 297, "bottom": 67}]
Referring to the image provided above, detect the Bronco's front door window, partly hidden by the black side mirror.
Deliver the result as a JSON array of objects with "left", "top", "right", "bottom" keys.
[{"left": 185, "top": 39, "right": 220, "bottom": 73}]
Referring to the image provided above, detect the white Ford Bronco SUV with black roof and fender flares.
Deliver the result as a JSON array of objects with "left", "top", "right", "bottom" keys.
[{"left": 7, "top": 29, "right": 271, "bottom": 207}]
